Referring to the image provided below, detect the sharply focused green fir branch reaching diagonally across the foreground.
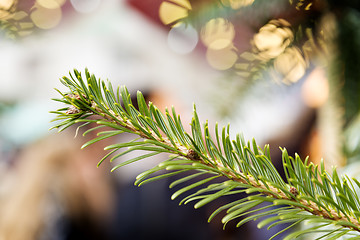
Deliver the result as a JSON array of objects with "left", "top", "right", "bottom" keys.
[{"left": 53, "top": 69, "right": 360, "bottom": 239}]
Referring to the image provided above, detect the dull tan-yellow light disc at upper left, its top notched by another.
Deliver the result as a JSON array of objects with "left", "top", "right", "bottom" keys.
[{"left": 30, "top": 4, "right": 62, "bottom": 29}]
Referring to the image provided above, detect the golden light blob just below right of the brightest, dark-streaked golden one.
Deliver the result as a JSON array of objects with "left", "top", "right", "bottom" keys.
[{"left": 274, "top": 47, "right": 306, "bottom": 84}]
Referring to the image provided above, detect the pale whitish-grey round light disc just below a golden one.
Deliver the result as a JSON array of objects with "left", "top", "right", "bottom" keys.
[{"left": 168, "top": 23, "right": 199, "bottom": 54}]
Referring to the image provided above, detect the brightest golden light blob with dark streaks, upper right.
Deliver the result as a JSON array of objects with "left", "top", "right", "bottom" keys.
[{"left": 253, "top": 19, "right": 294, "bottom": 60}]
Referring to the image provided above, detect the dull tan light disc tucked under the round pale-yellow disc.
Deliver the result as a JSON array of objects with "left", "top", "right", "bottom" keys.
[{"left": 206, "top": 45, "right": 238, "bottom": 70}]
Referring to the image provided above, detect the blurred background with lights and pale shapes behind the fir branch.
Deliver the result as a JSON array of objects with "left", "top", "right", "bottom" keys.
[{"left": 0, "top": 0, "right": 360, "bottom": 240}]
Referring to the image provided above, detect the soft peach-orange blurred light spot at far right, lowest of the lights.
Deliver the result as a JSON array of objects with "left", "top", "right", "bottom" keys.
[{"left": 301, "top": 68, "right": 329, "bottom": 108}]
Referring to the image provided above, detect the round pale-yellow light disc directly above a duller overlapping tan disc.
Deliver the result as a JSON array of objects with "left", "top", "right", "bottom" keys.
[{"left": 200, "top": 18, "right": 235, "bottom": 50}]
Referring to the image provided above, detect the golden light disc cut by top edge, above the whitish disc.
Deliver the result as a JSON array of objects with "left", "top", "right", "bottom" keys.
[{"left": 159, "top": 0, "right": 191, "bottom": 25}]
